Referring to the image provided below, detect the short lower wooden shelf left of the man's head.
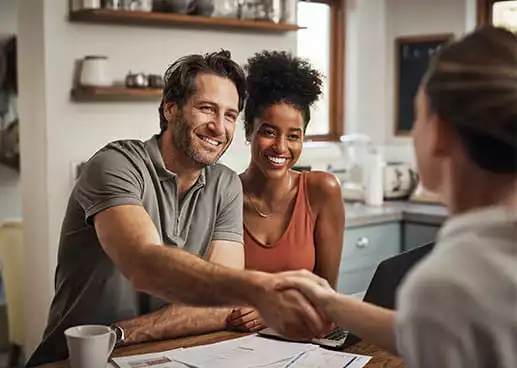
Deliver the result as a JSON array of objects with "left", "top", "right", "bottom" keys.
[{"left": 72, "top": 86, "right": 162, "bottom": 102}]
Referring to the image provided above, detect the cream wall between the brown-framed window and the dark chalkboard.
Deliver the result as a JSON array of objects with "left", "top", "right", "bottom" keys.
[{"left": 346, "top": 0, "right": 476, "bottom": 162}]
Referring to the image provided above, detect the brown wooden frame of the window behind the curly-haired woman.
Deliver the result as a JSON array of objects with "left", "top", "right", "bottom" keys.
[{"left": 301, "top": 0, "right": 346, "bottom": 142}]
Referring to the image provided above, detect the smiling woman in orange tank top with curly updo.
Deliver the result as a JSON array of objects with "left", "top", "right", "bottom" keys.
[{"left": 228, "top": 51, "right": 345, "bottom": 332}]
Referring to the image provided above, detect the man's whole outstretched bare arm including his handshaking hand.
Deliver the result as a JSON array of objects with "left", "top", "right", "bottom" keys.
[{"left": 94, "top": 205, "right": 326, "bottom": 338}]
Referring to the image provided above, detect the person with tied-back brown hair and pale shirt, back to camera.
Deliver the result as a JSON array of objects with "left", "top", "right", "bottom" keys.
[{"left": 274, "top": 26, "right": 517, "bottom": 368}]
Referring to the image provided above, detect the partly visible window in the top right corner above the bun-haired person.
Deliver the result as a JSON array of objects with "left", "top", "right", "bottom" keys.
[{"left": 477, "top": 0, "right": 517, "bottom": 28}]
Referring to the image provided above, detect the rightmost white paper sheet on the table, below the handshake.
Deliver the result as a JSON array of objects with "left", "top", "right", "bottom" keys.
[{"left": 284, "top": 348, "right": 371, "bottom": 368}]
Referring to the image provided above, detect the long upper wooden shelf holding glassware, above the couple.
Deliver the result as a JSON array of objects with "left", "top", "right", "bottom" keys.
[{"left": 70, "top": 9, "right": 303, "bottom": 33}]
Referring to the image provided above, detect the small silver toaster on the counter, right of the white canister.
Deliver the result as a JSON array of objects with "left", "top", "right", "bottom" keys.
[{"left": 383, "top": 162, "right": 418, "bottom": 199}]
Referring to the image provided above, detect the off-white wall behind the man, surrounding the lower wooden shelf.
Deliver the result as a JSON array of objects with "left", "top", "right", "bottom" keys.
[{"left": 19, "top": 0, "right": 296, "bottom": 352}]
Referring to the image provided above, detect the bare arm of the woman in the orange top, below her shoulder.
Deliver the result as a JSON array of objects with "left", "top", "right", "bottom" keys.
[{"left": 307, "top": 171, "right": 345, "bottom": 289}]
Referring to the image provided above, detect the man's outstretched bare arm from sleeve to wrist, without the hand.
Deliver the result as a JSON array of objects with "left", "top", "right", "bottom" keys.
[{"left": 94, "top": 205, "right": 252, "bottom": 306}]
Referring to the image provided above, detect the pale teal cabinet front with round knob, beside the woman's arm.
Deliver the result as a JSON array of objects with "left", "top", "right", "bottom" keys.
[{"left": 337, "top": 221, "right": 401, "bottom": 294}]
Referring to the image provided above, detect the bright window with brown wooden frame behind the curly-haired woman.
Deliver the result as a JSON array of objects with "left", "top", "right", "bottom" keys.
[{"left": 297, "top": 0, "right": 345, "bottom": 140}]
